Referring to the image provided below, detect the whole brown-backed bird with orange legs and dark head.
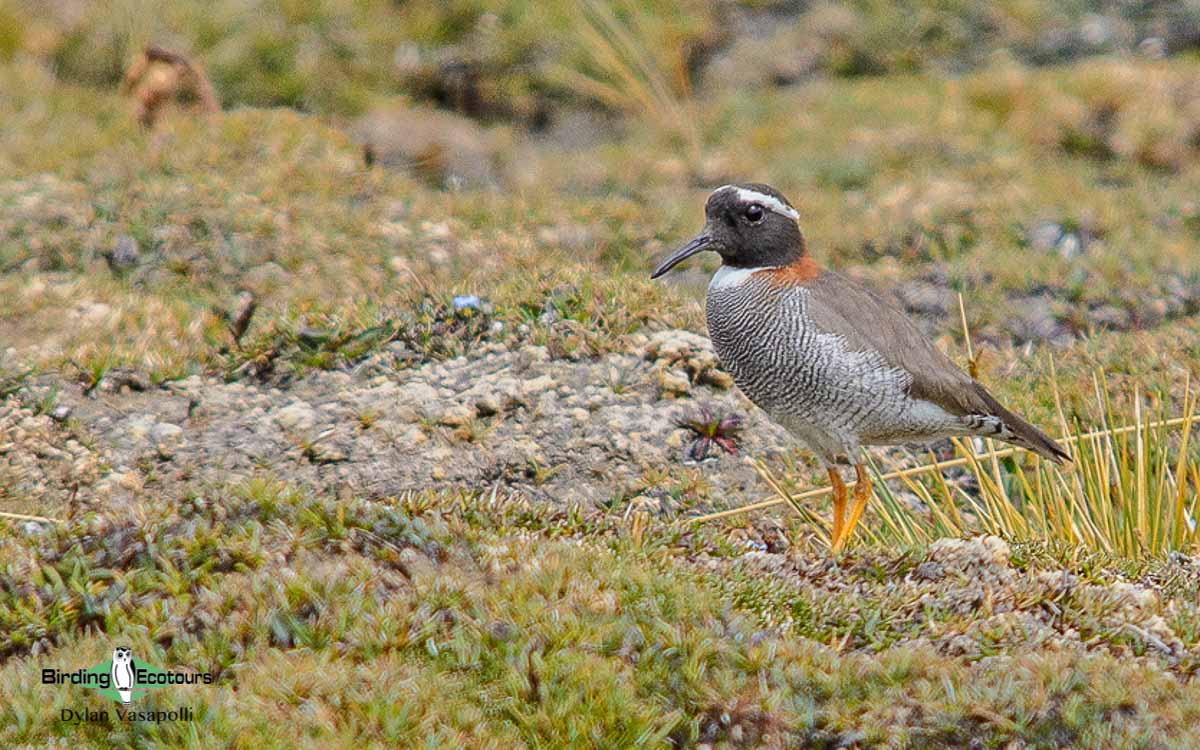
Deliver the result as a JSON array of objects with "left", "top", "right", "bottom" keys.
[{"left": 650, "top": 182, "right": 1070, "bottom": 554}]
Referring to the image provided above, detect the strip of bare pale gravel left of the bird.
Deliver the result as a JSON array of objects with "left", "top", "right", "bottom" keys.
[{"left": 0, "top": 330, "right": 816, "bottom": 510}]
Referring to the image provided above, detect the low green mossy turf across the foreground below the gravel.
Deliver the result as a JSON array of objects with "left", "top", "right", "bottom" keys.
[{"left": 7, "top": 478, "right": 1198, "bottom": 748}]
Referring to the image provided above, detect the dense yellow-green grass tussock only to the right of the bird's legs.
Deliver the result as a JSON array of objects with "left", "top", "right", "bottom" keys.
[{"left": 866, "top": 386, "right": 1200, "bottom": 557}]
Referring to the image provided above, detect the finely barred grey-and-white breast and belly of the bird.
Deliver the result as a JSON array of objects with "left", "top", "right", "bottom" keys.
[{"left": 704, "top": 266, "right": 967, "bottom": 460}]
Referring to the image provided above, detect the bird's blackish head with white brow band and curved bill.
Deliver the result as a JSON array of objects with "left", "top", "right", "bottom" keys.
[{"left": 650, "top": 184, "right": 804, "bottom": 278}]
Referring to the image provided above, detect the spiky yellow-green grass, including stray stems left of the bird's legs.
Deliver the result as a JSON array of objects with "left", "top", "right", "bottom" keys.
[{"left": 724, "top": 365, "right": 1200, "bottom": 558}]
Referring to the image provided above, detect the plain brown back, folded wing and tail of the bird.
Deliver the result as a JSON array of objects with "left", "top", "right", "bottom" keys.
[{"left": 804, "top": 270, "right": 1068, "bottom": 462}]
